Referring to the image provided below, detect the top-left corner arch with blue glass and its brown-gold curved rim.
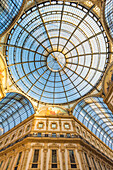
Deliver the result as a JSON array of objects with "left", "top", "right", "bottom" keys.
[{"left": 0, "top": 0, "right": 26, "bottom": 37}]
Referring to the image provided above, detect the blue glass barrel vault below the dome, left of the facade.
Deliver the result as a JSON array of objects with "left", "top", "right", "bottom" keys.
[{"left": 0, "top": 93, "right": 34, "bottom": 133}]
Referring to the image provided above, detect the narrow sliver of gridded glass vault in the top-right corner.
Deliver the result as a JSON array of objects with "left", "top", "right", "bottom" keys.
[{"left": 105, "top": 0, "right": 113, "bottom": 38}]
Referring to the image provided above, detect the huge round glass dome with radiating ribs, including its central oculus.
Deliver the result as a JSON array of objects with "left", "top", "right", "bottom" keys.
[{"left": 6, "top": 1, "right": 109, "bottom": 104}]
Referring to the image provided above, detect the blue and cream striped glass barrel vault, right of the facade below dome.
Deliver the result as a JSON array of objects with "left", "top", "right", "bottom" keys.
[{"left": 73, "top": 97, "right": 113, "bottom": 149}]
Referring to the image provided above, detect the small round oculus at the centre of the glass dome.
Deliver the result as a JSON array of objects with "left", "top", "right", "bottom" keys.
[{"left": 47, "top": 52, "right": 66, "bottom": 72}]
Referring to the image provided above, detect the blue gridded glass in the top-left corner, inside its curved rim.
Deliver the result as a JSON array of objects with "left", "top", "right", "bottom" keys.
[{"left": 0, "top": 0, "right": 23, "bottom": 34}]
